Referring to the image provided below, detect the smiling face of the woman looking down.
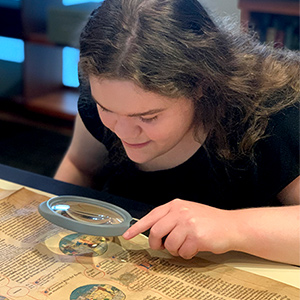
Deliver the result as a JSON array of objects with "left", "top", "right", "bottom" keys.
[{"left": 90, "top": 77, "right": 200, "bottom": 170}]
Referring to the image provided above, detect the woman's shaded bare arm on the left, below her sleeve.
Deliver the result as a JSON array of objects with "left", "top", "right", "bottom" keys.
[{"left": 54, "top": 115, "right": 107, "bottom": 186}]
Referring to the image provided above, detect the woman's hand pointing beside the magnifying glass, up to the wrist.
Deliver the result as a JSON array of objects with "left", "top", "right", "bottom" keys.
[{"left": 123, "top": 199, "right": 236, "bottom": 259}]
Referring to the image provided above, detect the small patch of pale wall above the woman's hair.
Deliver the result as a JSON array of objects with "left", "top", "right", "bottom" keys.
[{"left": 200, "top": 0, "right": 240, "bottom": 20}]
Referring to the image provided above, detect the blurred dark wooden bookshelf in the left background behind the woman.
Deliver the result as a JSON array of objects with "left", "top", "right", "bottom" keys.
[{"left": 0, "top": 0, "right": 100, "bottom": 121}]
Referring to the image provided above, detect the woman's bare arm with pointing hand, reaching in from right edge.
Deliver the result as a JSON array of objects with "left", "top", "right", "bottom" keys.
[{"left": 124, "top": 177, "right": 300, "bottom": 265}]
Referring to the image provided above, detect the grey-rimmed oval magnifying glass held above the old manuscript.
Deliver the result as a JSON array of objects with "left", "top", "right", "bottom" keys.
[{"left": 38, "top": 196, "right": 132, "bottom": 236}]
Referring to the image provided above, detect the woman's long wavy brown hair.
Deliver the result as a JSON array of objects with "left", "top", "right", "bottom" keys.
[{"left": 79, "top": 0, "right": 300, "bottom": 160}]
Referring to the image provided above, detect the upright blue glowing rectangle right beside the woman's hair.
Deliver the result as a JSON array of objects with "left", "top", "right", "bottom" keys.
[{"left": 63, "top": 47, "right": 79, "bottom": 87}]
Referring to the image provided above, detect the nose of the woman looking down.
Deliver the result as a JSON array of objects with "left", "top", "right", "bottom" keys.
[{"left": 113, "top": 116, "right": 142, "bottom": 142}]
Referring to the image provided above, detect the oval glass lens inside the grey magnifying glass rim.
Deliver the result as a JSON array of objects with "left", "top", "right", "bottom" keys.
[{"left": 51, "top": 201, "right": 124, "bottom": 225}]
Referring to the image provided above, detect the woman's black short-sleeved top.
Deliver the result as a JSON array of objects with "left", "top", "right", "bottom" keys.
[{"left": 78, "top": 84, "right": 299, "bottom": 209}]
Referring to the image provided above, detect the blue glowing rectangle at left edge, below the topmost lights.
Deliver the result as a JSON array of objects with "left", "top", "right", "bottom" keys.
[{"left": 0, "top": 36, "right": 25, "bottom": 63}]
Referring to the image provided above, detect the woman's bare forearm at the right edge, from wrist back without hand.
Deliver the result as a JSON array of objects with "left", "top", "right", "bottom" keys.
[{"left": 233, "top": 176, "right": 300, "bottom": 265}]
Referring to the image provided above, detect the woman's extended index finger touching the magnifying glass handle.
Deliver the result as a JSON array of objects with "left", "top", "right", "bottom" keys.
[{"left": 123, "top": 204, "right": 169, "bottom": 240}]
